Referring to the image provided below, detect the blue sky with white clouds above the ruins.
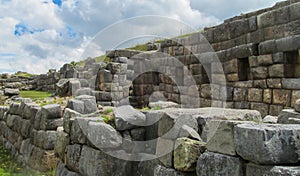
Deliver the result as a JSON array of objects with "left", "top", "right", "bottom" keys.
[{"left": 0, "top": 0, "right": 278, "bottom": 73}]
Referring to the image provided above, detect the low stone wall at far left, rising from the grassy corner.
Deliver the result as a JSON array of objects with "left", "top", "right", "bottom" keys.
[{"left": 0, "top": 99, "right": 62, "bottom": 172}]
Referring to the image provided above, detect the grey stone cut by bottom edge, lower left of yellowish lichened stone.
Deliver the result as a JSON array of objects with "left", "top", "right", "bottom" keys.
[{"left": 154, "top": 165, "right": 196, "bottom": 176}]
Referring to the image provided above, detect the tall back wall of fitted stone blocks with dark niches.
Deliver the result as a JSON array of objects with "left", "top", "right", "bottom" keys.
[{"left": 120, "top": 0, "right": 300, "bottom": 116}]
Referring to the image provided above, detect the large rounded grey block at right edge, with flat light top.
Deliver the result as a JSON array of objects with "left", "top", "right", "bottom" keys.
[{"left": 234, "top": 124, "right": 300, "bottom": 164}]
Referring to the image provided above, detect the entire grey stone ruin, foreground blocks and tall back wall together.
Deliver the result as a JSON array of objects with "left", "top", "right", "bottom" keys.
[{"left": 0, "top": 0, "right": 300, "bottom": 176}]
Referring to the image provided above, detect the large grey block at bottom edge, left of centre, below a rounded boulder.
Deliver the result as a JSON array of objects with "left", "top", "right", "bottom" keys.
[{"left": 79, "top": 146, "right": 132, "bottom": 176}]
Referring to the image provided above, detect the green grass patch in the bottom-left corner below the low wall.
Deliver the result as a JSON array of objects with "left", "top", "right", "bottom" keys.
[{"left": 0, "top": 145, "right": 47, "bottom": 176}]
